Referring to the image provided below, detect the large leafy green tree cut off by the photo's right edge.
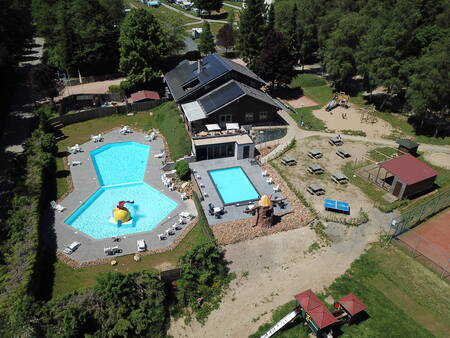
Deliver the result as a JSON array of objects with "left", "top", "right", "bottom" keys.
[{"left": 406, "top": 36, "right": 450, "bottom": 137}]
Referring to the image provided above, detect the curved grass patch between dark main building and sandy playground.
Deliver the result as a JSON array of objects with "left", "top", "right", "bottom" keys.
[{"left": 290, "top": 74, "right": 333, "bottom": 130}]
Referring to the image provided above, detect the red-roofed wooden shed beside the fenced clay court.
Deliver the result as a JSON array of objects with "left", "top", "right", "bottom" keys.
[{"left": 379, "top": 154, "right": 439, "bottom": 199}]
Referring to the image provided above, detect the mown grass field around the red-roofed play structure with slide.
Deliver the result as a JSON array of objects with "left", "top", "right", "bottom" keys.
[{"left": 250, "top": 244, "right": 450, "bottom": 338}]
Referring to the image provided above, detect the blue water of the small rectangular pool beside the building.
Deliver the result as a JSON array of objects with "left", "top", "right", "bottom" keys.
[{"left": 208, "top": 167, "right": 259, "bottom": 204}]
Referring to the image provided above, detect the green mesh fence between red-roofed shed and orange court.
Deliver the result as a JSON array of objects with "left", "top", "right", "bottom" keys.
[{"left": 389, "top": 188, "right": 450, "bottom": 240}]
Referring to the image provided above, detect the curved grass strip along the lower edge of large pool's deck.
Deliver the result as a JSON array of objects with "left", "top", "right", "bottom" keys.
[{"left": 52, "top": 194, "right": 209, "bottom": 297}]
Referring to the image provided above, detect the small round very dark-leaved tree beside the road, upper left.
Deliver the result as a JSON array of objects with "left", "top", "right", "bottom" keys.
[{"left": 29, "top": 63, "right": 58, "bottom": 99}]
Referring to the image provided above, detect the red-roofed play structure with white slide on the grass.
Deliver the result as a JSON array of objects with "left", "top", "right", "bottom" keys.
[{"left": 261, "top": 289, "right": 366, "bottom": 338}]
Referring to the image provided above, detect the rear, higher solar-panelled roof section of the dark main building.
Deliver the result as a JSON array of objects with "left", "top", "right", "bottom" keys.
[{"left": 164, "top": 54, "right": 265, "bottom": 103}]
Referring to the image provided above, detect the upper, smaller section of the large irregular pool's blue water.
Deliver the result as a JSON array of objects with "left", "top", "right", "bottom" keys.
[{"left": 91, "top": 142, "right": 150, "bottom": 185}]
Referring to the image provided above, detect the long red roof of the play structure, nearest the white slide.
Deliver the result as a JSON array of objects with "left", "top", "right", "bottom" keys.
[{"left": 295, "top": 289, "right": 338, "bottom": 330}]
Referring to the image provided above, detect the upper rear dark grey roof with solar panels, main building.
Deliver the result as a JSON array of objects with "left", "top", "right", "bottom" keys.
[{"left": 164, "top": 54, "right": 265, "bottom": 102}]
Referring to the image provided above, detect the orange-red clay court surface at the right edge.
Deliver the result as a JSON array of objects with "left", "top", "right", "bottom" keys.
[{"left": 398, "top": 209, "right": 450, "bottom": 277}]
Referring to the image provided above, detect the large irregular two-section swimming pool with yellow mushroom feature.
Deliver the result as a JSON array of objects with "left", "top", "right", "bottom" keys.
[{"left": 65, "top": 142, "right": 177, "bottom": 239}]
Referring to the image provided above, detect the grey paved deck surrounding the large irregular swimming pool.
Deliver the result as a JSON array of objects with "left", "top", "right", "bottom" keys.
[{"left": 42, "top": 129, "right": 197, "bottom": 263}]
